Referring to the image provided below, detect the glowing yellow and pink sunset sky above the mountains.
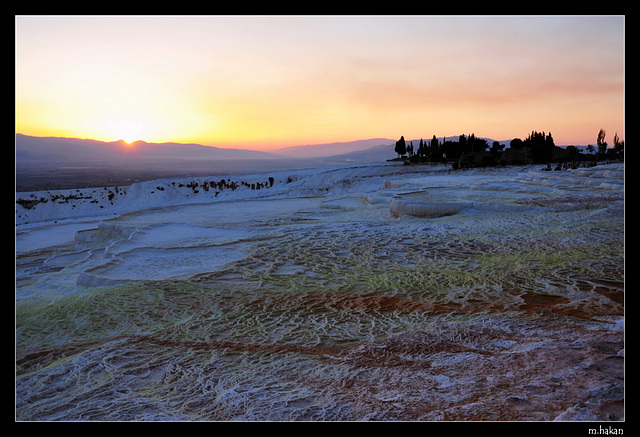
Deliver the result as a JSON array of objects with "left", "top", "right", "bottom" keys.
[{"left": 15, "top": 16, "right": 625, "bottom": 150}]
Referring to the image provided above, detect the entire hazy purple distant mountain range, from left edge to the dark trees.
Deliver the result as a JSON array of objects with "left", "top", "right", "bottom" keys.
[{"left": 15, "top": 134, "right": 596, "bottom": 191}]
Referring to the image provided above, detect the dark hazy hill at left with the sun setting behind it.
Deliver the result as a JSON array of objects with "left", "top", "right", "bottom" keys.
[{"left": 15, "top": 134, "right": 293, "bottom": 191}]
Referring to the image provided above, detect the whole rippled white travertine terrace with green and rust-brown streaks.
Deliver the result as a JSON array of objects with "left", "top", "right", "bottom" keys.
[{"left": 16, "top": 166, "right": 624, "bottom": 420}]
